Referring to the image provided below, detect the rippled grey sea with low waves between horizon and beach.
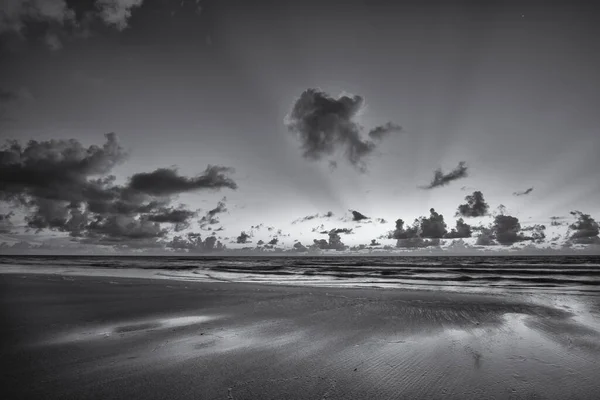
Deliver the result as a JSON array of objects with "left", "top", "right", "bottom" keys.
[{"left": 0, "top": 255, "right": 600, "bottom": 294}]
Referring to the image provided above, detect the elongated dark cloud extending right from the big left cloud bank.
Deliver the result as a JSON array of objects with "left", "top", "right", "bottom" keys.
[{"left": 129, "top": 165, "right": 237, "bottom": 196}]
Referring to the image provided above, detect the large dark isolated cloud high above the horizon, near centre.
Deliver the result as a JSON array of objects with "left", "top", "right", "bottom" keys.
[{"left": 285, "top": 89, "right": 404, "bottom": 172}]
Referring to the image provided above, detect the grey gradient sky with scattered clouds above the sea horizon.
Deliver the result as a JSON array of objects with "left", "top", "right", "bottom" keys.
[{"left": 0, "top": 0, "right": 600, "bottom": 253}]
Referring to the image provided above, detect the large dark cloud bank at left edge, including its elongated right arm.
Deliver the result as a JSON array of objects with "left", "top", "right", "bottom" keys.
[{"left": 0, "top": 133, "right": 236, "bottom": 246}]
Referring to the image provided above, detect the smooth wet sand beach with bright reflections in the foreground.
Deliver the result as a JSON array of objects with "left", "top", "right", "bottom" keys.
[{"left": 0, "top": 273, "right": 600, "bottom": 400}]
